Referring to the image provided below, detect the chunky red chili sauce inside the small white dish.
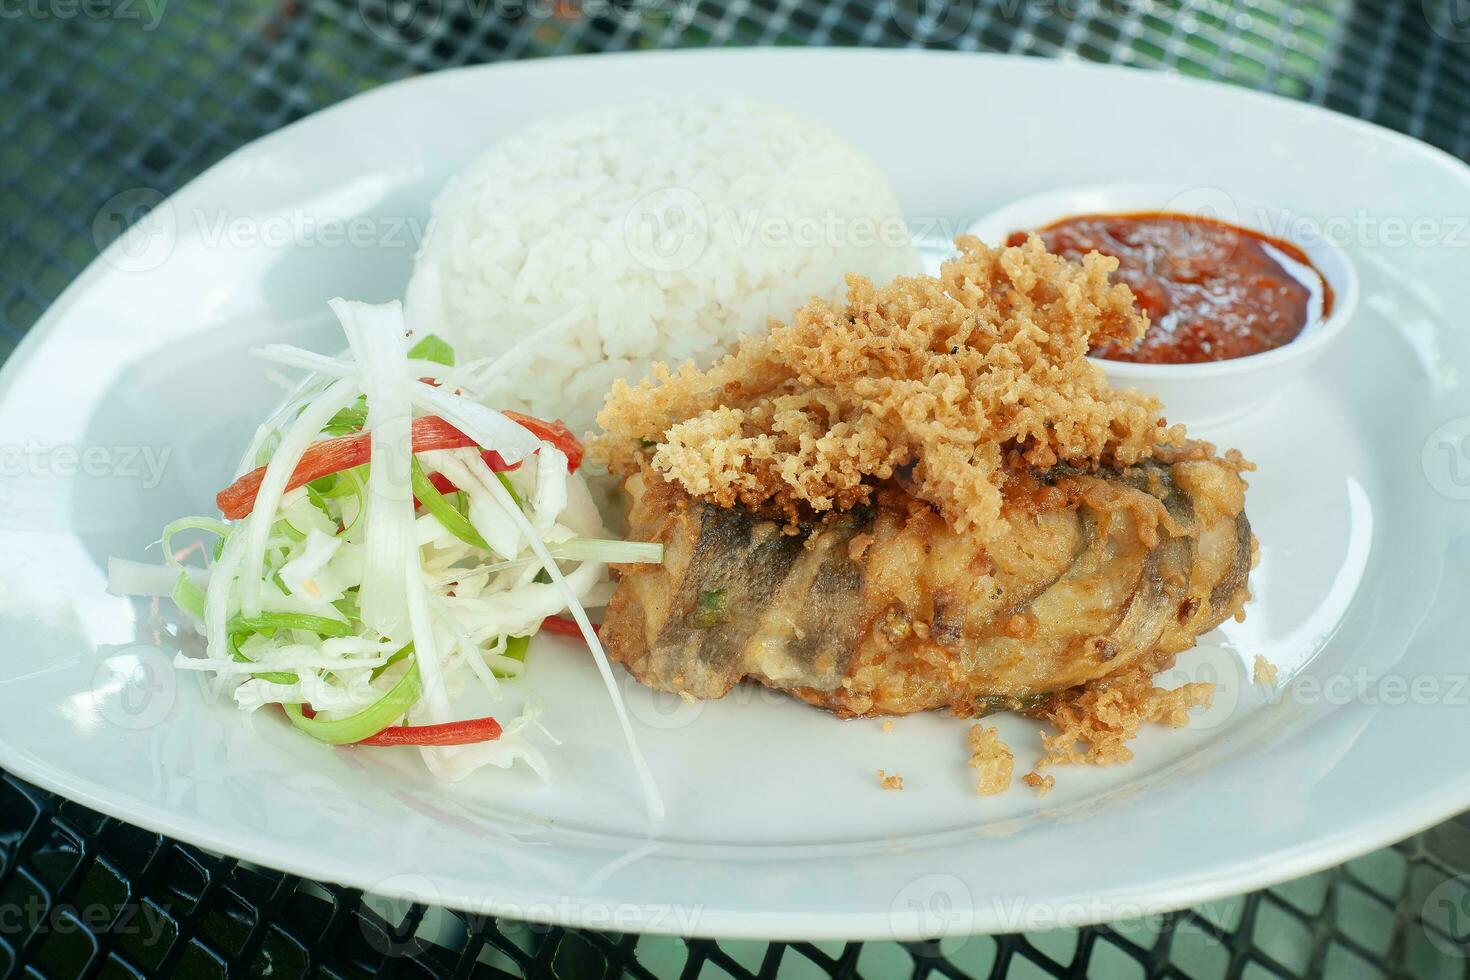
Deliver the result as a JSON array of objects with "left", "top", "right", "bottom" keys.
[{"left": 1008, "top": 212, "right": 1332, "bottom": 364}]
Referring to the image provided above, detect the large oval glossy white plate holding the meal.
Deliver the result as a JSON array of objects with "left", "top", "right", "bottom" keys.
[{"left": 0, "top": 50, "right": 1470, "bottom": 939}]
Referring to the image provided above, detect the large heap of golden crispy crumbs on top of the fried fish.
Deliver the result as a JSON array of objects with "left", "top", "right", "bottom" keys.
[{"left": 594, "top": 237, "right": 1183, "bottom": 539}]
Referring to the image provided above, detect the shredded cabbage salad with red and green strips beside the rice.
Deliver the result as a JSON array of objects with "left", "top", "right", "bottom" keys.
[{"left": 109, "top": 300, "right": 663, "bottom": 818}]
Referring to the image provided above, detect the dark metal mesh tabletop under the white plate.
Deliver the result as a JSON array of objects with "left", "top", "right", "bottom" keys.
[{"left": 0, "top": 0, "right": 1470, "bottom": 979}]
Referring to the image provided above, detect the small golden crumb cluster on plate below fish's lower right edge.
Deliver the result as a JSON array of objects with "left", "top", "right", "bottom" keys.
[{"left": 1036, "top": 669, "right": 1214, "bottom": 771}]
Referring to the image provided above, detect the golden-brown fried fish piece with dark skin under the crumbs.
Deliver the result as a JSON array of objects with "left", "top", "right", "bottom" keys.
[{"left": 601, "top": 444, "right": 1252, "bottom": 717}]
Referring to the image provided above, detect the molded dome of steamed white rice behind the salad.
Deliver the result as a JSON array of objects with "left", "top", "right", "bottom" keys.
[{"left": 407, "top": 101, "right": 919, "bottom": 432}]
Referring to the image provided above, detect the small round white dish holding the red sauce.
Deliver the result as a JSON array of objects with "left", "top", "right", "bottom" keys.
[{"left": 967, "top": 184, "right": 1358, "bottom": 426}]
